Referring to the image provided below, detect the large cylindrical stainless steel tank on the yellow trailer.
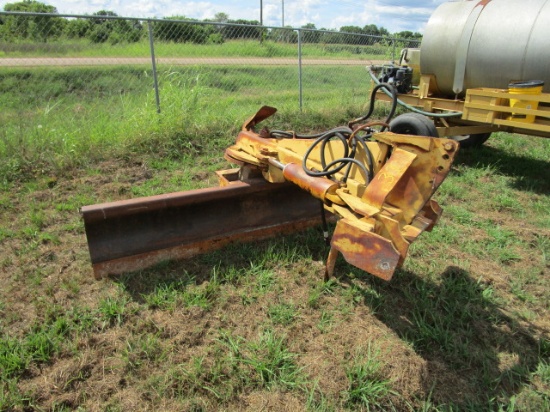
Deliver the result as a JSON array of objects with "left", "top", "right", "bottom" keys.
[{"left": 420, "top": 0, "right": 550, "bottom": 96}]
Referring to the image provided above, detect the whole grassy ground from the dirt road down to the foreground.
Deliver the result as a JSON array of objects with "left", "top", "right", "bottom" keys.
[{"left": 0, "top": 69, "right": 550, "bottom": 412}]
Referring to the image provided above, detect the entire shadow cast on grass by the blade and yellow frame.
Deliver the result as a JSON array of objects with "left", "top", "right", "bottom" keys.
[{"left": 108, "top": 220, "right": 548, "bottom": 411}]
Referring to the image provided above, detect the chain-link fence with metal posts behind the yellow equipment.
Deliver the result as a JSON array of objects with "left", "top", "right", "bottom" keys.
[{"left": 0, "top": 12, "right": 418, "bottom": 176}]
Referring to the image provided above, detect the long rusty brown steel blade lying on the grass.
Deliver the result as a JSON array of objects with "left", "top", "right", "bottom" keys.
[{"left": 81, "top": 179, "right": 328, "bottom": 278}]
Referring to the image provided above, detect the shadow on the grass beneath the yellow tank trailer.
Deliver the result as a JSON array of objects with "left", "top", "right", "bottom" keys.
[{"left": 455, "top": 146, "right": 550, "bottom": 194}]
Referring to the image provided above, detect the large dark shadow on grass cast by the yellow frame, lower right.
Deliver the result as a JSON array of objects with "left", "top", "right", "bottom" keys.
[{"left": 342, "top": 266, "right": 544, "bottom": 410}]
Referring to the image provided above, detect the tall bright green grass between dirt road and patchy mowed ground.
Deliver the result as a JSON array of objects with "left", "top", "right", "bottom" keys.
[{"left": 0, "top": 67, "right": 368, "bottom": 183}]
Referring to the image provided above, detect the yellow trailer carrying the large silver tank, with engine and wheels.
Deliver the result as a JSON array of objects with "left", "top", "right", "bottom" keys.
[{"left": 370, "top": 0, "right": 550, "bottom": 147}]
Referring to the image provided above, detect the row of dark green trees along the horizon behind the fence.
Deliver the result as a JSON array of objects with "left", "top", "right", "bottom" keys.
[{"left": 0, "top": 0, "right": 422, "bottom": 45}]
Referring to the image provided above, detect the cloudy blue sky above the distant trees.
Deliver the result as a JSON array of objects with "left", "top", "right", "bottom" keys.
[{"left": 0, "top": 0, "right": 447, "bottom": 33}]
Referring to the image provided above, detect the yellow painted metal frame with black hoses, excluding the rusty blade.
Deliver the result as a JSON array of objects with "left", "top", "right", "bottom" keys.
[{"left": 225, "top": 107, "right": 458, "bottom": 280}]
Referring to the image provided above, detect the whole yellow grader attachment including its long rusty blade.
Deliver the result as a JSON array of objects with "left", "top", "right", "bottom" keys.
[{"left": 81, "top": 106, "right": 458, "bottom": 280}]
